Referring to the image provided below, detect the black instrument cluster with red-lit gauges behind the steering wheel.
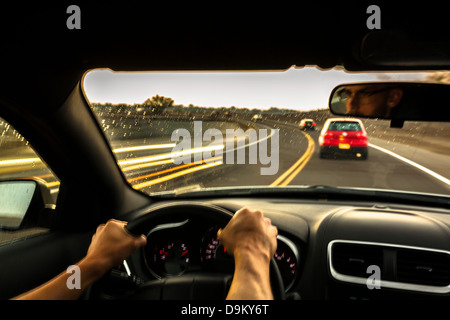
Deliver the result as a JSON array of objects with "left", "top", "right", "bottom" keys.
[{"left": 133, "top": 215, "right": 302, "bottom": 291}]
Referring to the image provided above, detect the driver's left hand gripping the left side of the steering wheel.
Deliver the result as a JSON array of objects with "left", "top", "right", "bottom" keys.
[{"left": 86, "top": 220, "right": 147, "bottom": 272}]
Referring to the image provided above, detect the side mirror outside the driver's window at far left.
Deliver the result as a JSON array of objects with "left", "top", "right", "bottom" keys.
[{"left": 0, "top": 180, "right": 54, "bottom": 230}]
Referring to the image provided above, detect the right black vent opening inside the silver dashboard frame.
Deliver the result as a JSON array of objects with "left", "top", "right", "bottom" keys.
[{"left": 397, "top": 249, "right": 450, "bottom": 287}]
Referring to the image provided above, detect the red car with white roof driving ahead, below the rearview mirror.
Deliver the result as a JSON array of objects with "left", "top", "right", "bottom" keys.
[{"left": 319, "top": 118, "right": 369, "bottom": 159}]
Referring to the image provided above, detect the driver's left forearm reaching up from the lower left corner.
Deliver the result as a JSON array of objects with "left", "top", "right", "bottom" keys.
[{"left": 13, "top": 258, "right": 104, "bottom": 300}]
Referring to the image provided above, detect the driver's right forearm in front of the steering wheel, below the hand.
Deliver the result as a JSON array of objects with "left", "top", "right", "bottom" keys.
[{"left": 227, "top": 252, "right": 273, "bottom": 300}]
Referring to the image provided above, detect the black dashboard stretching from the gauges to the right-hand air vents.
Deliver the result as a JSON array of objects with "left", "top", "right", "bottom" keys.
[{"left": 121, "top": 198, "right": 450, "bottom": 300}]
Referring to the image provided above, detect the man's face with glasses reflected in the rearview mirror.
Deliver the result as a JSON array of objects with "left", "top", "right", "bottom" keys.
[{"left": 334, "top": 84, "right": 403, "bottom": 118}]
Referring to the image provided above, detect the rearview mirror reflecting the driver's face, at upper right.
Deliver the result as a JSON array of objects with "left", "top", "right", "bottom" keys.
[{"left": 329, "top": 82, "right": 450, "bottom": 121}]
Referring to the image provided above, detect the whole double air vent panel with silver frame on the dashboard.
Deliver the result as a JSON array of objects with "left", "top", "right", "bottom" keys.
[{"left": 328, "top": 240, "right": 450, "bottom": 294}]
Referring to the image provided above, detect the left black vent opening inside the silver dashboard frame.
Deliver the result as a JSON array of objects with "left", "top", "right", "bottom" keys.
[{"left": 331, "top": 242, "right": 383, "bottom": 278}]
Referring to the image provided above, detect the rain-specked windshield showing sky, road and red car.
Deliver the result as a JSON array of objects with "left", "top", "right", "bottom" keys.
[{"left": 83, "top": 67, "right": 450, "bottom": 195}]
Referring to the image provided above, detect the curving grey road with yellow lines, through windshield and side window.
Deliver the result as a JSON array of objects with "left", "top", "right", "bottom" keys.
[{"left": 0, "top": 117, "right": 450, "bottom": 195}]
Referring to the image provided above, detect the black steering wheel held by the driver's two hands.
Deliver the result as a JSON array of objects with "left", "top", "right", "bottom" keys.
[{"left": 107, "top": 202, "right": 285, "bottom": 300}]
